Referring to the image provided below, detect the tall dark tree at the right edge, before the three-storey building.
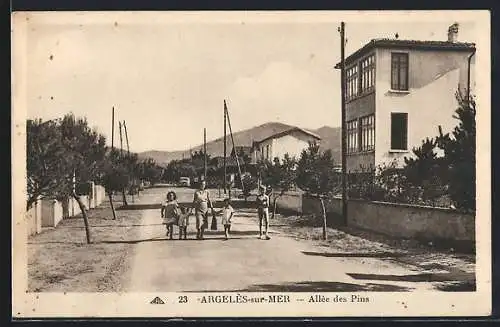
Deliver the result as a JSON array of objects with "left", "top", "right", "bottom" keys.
[{"left": 437, "top": 91, "right": 476, "bottom": 211}]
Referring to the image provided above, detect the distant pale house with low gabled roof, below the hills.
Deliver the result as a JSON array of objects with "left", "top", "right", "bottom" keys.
[{"left": 251, "top": 127, "right": 321, "bottom": 163}]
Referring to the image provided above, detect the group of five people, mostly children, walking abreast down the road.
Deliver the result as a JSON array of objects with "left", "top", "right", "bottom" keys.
[{"left": 161, "top": 181, "right": 270, "bottom": 240}]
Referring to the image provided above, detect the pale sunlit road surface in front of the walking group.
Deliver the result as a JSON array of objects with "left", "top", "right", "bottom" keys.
[{"left": 128, "top": 189, "right": 448, "bottom": 292}]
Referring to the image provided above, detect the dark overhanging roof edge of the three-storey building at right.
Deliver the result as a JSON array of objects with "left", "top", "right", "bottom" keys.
[{"left": 335, "top": 38, "right": 476, "bottom": 69}]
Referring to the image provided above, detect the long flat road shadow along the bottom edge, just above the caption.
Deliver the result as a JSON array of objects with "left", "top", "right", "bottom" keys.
[{"left": 187, "top": 281, "right": 412, "bottom": 293}]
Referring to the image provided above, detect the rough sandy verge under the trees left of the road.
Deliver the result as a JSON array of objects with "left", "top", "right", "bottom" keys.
[{"left": 28, "top": 193, "right": 142, "bottom": 292}]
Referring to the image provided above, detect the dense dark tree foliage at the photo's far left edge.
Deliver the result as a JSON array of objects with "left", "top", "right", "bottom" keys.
[{"left": 27, "top": 113, "right": 105, "bottom": 208}]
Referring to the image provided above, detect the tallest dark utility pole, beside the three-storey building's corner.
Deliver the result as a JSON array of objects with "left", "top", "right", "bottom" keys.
[{"left": 340, "top": 22, "right": 348, "bottom": 225}]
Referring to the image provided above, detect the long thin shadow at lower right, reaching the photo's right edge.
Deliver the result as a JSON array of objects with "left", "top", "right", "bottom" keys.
[{"left": 347, "top": 273, "right": 475, "bottom": 283}]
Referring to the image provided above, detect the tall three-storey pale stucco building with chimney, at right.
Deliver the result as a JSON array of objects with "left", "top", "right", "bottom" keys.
[{"left": 336, "top": 24, "right": 475, "bottom": 172}]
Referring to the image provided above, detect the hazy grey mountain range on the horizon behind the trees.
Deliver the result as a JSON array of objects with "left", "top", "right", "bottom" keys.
[{"left": 138, "top": 122, "right": 341, "bottom": 165}]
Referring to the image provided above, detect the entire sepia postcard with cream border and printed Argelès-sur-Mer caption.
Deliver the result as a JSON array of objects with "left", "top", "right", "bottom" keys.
[{"left": 12, "top": 10, "right": 491, "bottom": 317}]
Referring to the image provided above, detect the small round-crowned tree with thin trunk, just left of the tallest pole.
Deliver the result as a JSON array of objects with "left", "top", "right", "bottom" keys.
[{"left": 297, "top": 142, "right": 336, "bottom": 240}]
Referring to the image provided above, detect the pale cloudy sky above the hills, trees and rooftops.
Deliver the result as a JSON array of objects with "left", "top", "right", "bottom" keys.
[{"left": 21, "top": 13, "right": 476, "bottom": 152}]
